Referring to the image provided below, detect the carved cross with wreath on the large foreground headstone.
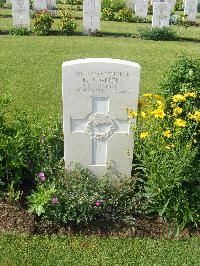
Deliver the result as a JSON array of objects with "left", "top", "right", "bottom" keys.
[{"left": 71, "top": 97, "right": 129, "bottom": 166}]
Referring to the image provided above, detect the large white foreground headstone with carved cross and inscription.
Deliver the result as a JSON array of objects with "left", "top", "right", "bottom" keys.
[{"left": 62, "top": 58, "right": 140, "bottom": 176}]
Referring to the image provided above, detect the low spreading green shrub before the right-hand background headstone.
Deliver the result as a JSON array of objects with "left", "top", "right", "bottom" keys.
[{"left": 139, "top": 27, "right": 177, "bottom": 41}]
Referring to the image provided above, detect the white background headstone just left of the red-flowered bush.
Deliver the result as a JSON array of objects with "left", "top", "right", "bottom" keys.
[{"left": 12, "top": 0, "right": 30, "bottom": 29}]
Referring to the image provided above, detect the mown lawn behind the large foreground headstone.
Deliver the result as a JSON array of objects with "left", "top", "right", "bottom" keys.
[{"left": 0, "top": 33, "right": 200, "bottom": 123}]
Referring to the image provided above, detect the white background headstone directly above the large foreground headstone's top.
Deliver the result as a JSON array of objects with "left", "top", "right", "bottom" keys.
[{"left": 83, "top": 0, "right": 101, "bottom": 34}]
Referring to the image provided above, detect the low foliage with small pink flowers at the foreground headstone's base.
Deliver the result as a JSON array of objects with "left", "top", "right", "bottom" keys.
[{"left": 29, "top": 166, "right": 139, "bottom": 225}]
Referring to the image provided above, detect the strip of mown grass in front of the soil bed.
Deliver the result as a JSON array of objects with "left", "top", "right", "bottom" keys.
[{"left": 0, "top": 234, "right": 200, "bottom": 266}]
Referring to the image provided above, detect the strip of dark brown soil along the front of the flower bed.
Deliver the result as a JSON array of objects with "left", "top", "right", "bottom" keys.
[{"left": 0, "top": 199, "right": 200, "bottom": 238}]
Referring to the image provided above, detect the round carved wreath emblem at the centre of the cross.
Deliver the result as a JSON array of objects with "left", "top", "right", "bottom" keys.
[{"left": 85, "top": 113, "right": 115, "bottom": 140}]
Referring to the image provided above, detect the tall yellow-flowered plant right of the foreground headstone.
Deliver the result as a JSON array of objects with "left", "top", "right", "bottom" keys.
[{"left": 129, "top": 92, "right": 200, "bottom": 234}]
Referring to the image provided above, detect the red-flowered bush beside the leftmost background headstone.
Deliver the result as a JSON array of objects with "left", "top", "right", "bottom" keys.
[{"left": 33, "top": 10, "right": 54, "bottom": 35}]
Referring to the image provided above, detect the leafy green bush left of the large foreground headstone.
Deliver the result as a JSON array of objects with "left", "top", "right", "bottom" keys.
[{"left": 0, "top": 95, "right": 63, "bottom": 199}]
